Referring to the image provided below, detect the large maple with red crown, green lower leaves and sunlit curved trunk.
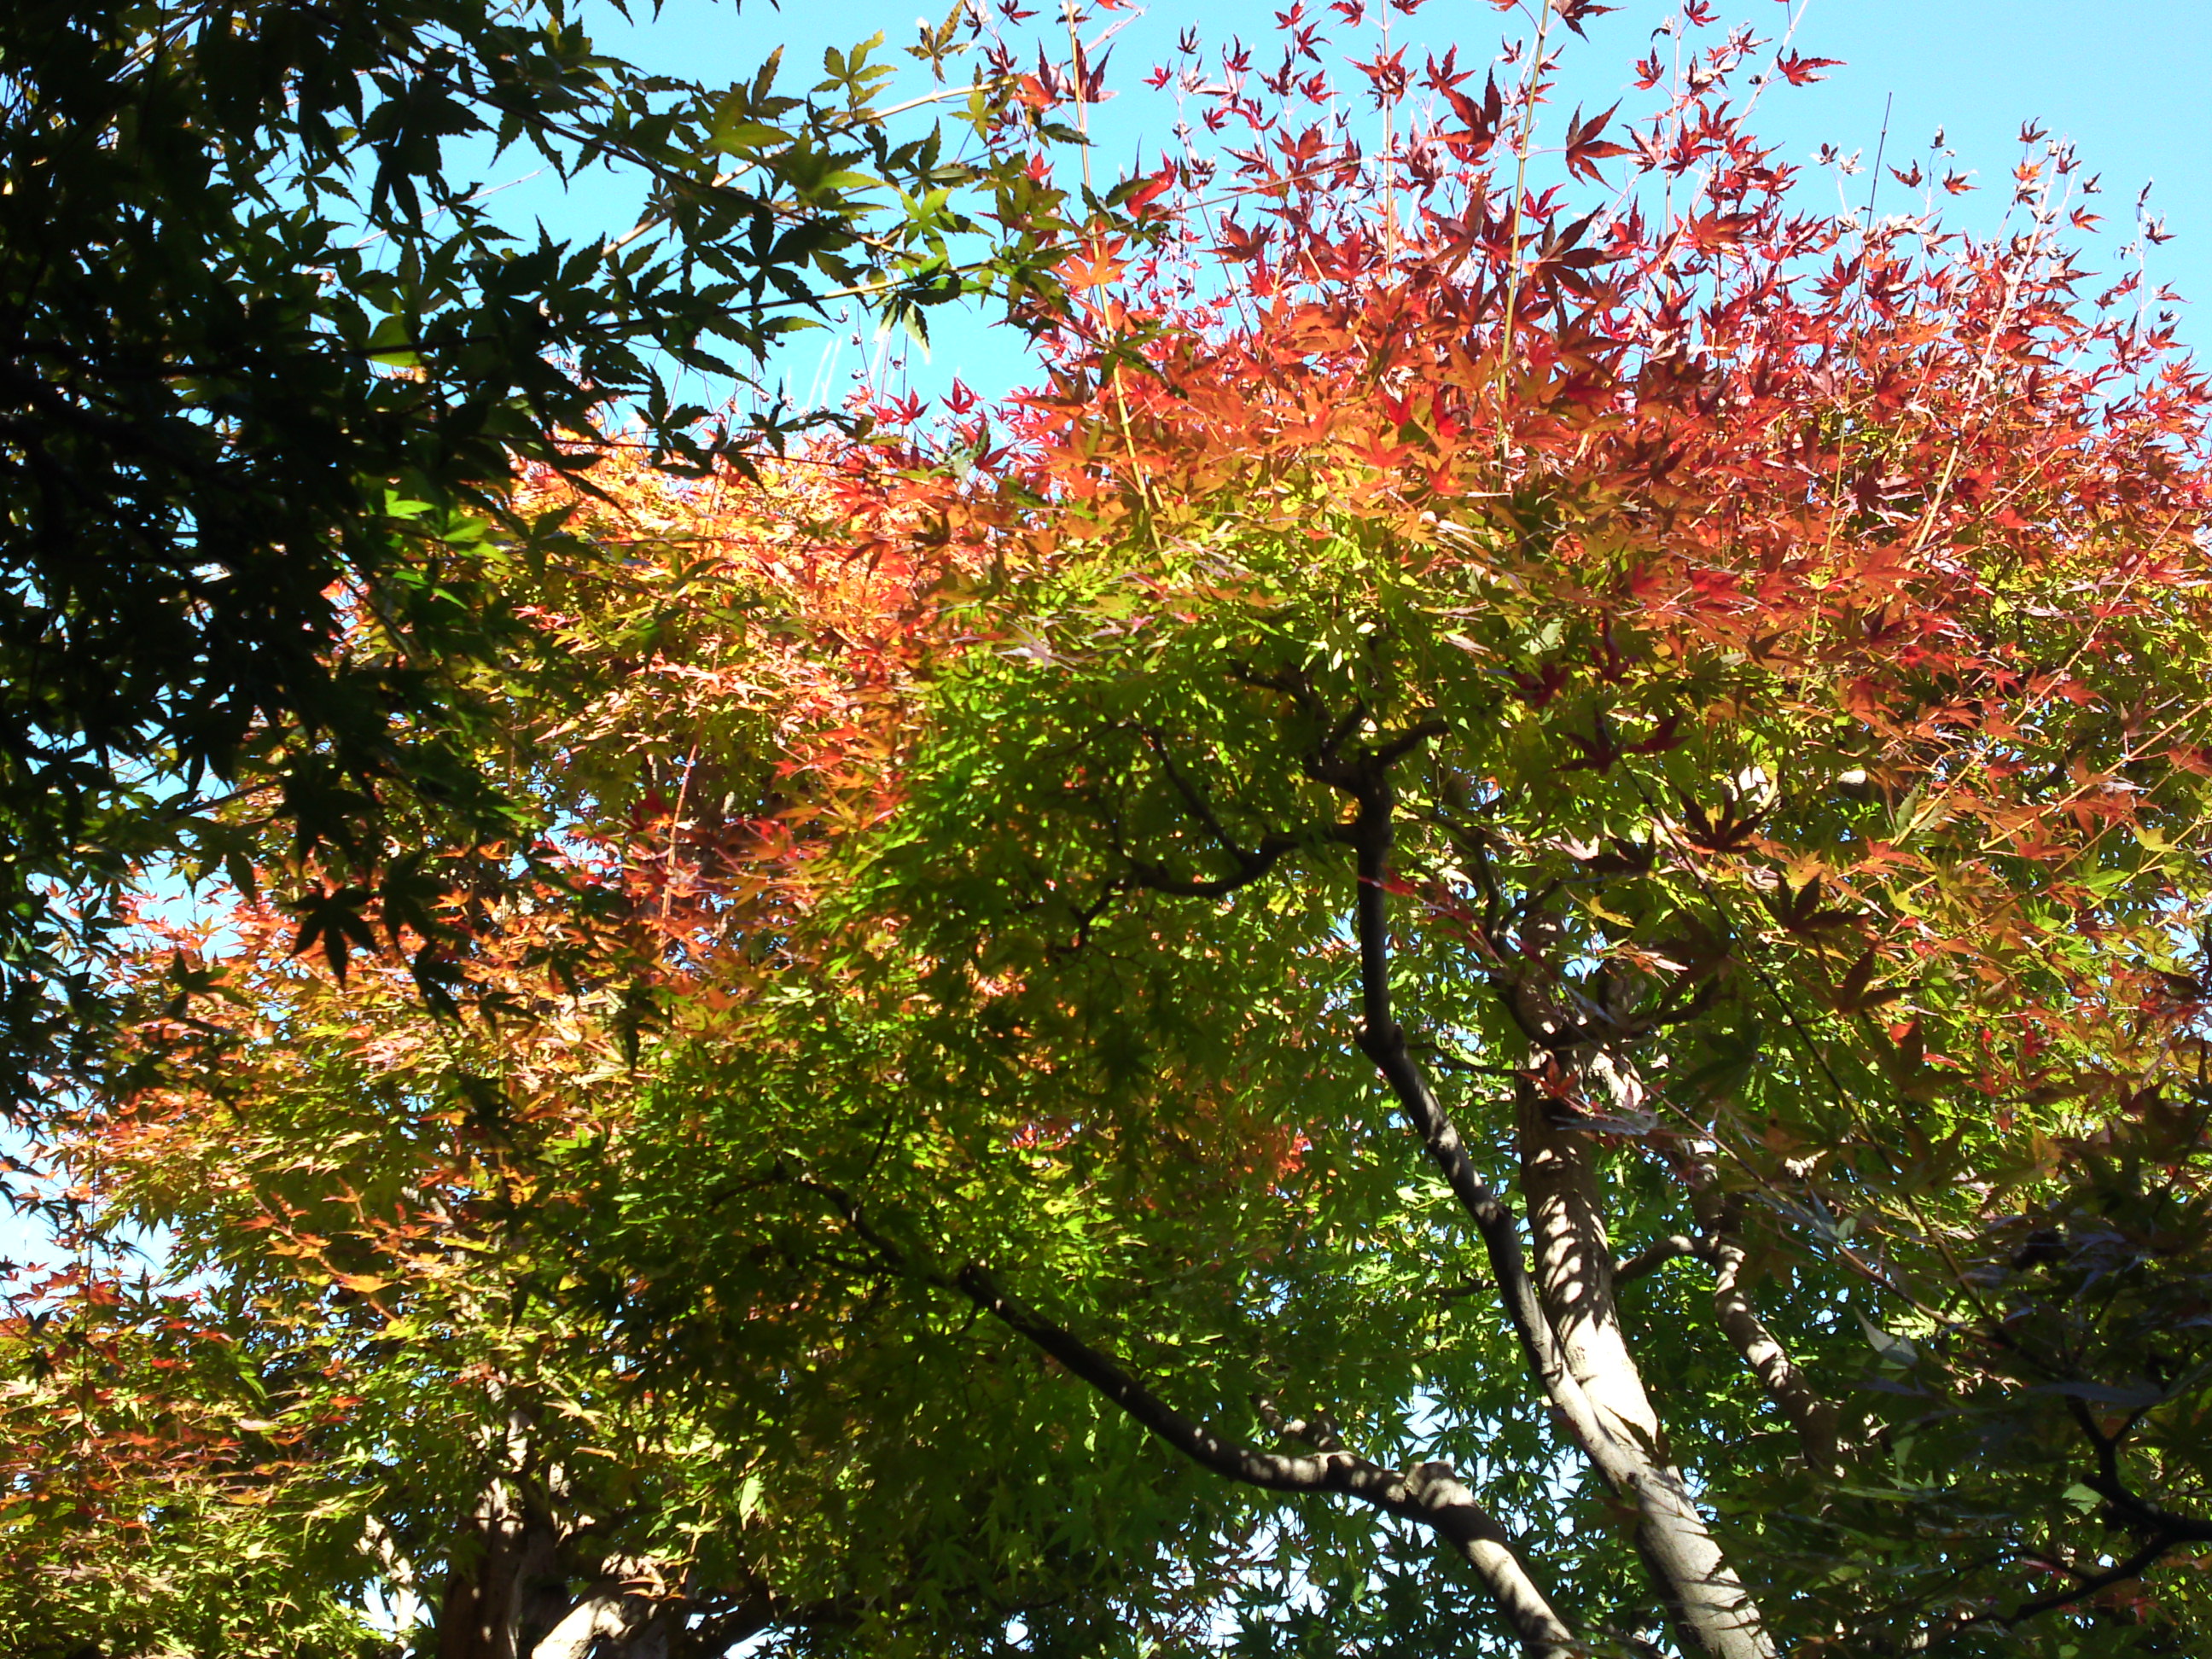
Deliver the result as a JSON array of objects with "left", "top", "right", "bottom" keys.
[{"left": 645, "top": 4, "right": 2212, "bottom": 1655}]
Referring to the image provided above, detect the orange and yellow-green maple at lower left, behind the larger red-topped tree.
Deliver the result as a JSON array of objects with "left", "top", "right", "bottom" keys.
[{"left": 0, "top": 451, "right": 1247, "bottom": 1659}]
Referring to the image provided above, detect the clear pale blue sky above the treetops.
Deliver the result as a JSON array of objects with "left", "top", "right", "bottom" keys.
[{"left": 498, "top": 0, "right": 2212, "bottom": 411}]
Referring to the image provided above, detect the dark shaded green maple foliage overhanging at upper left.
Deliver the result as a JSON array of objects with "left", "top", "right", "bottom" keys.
[{"left": 0, "top": 0, "right": 1057, "bottom": 1132}]
